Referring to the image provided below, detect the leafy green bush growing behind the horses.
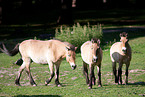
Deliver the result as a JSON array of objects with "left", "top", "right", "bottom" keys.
[{"left": 55, "top": 23, "right": 102, "bottom": 51}]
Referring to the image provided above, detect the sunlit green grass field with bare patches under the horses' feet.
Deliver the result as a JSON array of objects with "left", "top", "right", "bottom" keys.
[{"left": 0, "top": 33, "right": 145, "bottom": 97}]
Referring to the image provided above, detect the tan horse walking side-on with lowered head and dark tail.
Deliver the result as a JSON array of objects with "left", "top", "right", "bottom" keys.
[{"left": 1, "top": 40, "right": 77, "bottom": 86}]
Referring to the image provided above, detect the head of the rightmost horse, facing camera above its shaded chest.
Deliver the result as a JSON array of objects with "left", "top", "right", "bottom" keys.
[{"left": 120, "top": 32, "right": 128, "bottom": 54}]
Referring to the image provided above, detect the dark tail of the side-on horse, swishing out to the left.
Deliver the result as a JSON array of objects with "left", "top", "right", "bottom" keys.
[{"left": 0, "top": 43, "right": 19, "bottom": 56}]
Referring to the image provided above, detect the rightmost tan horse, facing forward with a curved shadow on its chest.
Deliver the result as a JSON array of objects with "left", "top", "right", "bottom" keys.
[{"left": 110, "top": 32, "right": 131, "bottom": 84}]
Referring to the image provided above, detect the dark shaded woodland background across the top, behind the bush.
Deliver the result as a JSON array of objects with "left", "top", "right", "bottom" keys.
[{"left": 0, "top": 0, "right": 145, "bottom": 40}]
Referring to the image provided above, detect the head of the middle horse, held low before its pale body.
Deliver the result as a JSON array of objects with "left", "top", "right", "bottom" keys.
[{"left": 91, "top": 38, "right": 100, "bottom": 63}]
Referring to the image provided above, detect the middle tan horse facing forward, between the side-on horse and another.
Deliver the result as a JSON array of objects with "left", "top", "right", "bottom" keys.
[{"left": 81, "top": 38, "right": 103, "bottom": 89}]
